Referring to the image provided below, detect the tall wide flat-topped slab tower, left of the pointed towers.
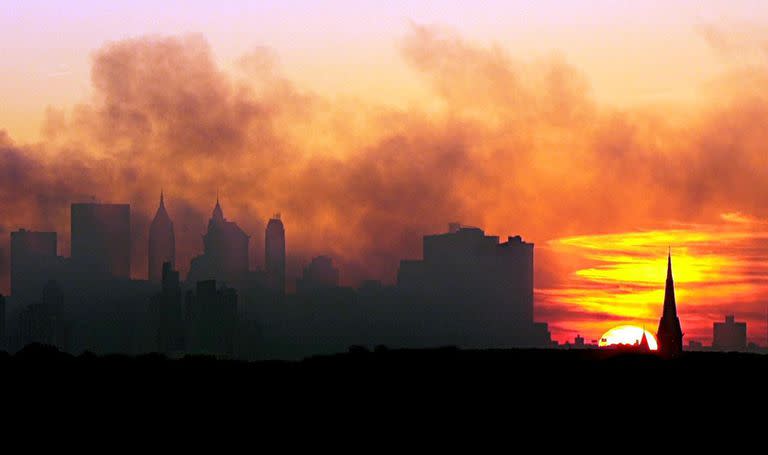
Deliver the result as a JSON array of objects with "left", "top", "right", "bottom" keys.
[{"left": 72, "top": 203, "right": 131, "bottom": 278}]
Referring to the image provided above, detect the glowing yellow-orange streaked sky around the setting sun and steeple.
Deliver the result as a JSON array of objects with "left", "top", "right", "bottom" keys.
[{"left": 537, "top": 216, "right": 768, "bottom": 344}]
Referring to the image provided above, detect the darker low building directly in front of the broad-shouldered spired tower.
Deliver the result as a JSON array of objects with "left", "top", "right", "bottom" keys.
[{"left": 186, "top": 280, "right": 237, "bottom": 355}]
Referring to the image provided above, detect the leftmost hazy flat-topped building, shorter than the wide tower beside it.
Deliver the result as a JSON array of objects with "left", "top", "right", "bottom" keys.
[{"left": 11, "top": 229, "right": 58, "bottom": 302}]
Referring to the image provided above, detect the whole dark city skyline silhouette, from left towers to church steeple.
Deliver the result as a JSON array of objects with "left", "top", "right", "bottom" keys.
[{"left": 2, "top": 192, "right": 757, "bottom": 359}]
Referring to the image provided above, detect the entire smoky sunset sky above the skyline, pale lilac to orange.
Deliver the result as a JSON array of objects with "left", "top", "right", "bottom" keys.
[{"left": 0, "top": 0, "right": 768, "bottom": 344}]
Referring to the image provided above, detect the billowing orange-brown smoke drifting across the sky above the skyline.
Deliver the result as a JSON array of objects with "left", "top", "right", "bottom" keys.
[{"left": 0, "top": 26, "right": 768, "bottom": 302}]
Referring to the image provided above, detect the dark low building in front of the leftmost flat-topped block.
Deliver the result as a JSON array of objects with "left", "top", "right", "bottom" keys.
[{"left": 19, "top": 281, "right": 69, "bottom": 350}]
